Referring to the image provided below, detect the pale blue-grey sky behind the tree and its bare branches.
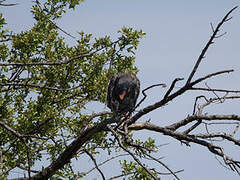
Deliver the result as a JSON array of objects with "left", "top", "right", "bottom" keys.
[{"left": 0, "top": 0, "right": 240, "bottom": 180}]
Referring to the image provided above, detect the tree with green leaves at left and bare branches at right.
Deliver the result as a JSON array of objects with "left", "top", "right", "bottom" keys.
[{"left": 0, "top": 0, "right": 240, "bottom": 179}]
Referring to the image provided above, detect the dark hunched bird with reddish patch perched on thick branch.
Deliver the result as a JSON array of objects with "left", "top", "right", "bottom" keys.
[{"left": 107, "top": 72, "right": 140, "bottom": 116}]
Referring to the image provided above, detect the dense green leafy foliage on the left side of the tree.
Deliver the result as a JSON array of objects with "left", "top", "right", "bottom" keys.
[{"left": 0, "top": 0, "right": 145, "bottom": 178}]
